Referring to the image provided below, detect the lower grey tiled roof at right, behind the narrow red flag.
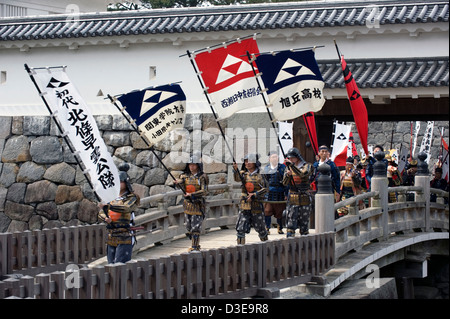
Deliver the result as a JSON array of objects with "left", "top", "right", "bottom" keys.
[{"left": 318, "top": 57, "right": 449, "bottom": 89}]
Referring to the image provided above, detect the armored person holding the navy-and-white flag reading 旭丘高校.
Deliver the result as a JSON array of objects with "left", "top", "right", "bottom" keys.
[{"left": 283, "top": 147, "right": 313, "bottom": 237}]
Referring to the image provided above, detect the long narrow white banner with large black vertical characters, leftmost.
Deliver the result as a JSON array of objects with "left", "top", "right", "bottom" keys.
[{"left": 32, "top": 68, "right": 120, "bottom": 203}]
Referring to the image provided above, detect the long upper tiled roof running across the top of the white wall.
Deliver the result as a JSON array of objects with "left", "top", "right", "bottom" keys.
[{"left": 0, "top": 0, "right": 449, "bottom": 41}]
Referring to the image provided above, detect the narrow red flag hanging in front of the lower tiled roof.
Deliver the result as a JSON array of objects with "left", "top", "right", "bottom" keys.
[{"left": 341, "top": 55, "right": 369, "bottom": 154}]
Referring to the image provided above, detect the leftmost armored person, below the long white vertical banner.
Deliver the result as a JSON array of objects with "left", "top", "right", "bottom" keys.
[{"left": 98, "top": 163, "right": 140, "bottom": 264}]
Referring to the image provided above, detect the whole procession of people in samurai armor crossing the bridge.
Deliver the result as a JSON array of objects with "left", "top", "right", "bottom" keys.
[{"left": 99, "top": 145, "right": 448, "bottom": 263}]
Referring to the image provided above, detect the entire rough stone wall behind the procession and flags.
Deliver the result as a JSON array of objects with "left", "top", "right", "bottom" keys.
[{"left": 0, "top": 113, "right": 448, "bottom": 232}]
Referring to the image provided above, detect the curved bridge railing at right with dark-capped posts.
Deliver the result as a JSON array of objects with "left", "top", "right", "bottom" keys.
[{"left": 315, "top": 154, "right": 449, "bottom": 261}]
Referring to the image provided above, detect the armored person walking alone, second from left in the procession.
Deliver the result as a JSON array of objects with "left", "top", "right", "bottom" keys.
[{"left": 174, "top": 155, "right": 209, "bottom": 251}]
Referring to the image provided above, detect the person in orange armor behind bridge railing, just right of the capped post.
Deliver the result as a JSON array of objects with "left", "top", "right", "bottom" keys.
[{"left": 338, "top": 156, "right": 361, "bottom": 217}]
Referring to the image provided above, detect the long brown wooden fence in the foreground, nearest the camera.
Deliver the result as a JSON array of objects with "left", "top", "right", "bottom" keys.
[{"left": 0, "top": 233, "right": 334, "bottom": 299}]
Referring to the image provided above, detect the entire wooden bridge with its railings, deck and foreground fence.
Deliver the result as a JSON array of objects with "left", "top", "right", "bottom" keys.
[{"left": 0, "top": 152, "right": 449, "bottom": 299}]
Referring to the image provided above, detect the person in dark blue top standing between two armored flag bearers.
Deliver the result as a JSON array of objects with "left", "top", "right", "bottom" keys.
[{"left": 263, "top": 151, "right": 287, "bottom": 234}]
